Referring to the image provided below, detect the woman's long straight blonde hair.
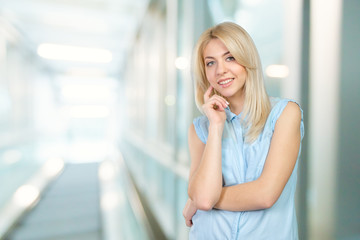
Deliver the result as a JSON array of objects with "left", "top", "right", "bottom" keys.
[{"left": 193, "top": 22, "right": 271, "bottom": 142}]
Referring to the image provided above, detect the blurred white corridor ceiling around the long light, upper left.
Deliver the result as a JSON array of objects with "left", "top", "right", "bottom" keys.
[{"left": 0, "top": 0, "right": 148, "bottom": 74}]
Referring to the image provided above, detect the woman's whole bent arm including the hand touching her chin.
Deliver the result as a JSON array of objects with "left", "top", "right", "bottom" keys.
[{"left": 188, "top": 86, "right": 228, "bottom": 211}]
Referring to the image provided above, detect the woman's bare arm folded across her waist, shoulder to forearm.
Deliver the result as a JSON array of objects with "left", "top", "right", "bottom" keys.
[{"left": 214, "top": 102, "right": 301, "bottom": 211}]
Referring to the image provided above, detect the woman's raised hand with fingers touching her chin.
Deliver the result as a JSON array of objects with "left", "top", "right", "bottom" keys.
[{"left": 202, "top": 86, "right": 229, "bottom": 124}]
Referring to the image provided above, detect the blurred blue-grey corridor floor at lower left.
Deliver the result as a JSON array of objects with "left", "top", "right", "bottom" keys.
[{"left": 6, "top": 163, "right": 102, "bottom": 240}]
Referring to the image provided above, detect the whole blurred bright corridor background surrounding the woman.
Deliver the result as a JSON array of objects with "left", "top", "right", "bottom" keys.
[{"left": 0, "top": 0, "right": 360, "bottom": 240}]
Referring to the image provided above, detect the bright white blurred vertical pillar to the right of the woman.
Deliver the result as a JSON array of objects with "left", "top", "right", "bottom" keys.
[{"left": 308, "top": 0, "right": 342, "bottom": 240}]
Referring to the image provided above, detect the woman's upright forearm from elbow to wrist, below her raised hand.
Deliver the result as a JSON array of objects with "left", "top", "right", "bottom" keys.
[{"left": 188, "top": 125, "right": 223, "bottom": 210}]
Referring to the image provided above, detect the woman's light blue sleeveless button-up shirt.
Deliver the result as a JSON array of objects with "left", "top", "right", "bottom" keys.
[{"left": 189, "top": 99, "right": 304, "bottom": 240}]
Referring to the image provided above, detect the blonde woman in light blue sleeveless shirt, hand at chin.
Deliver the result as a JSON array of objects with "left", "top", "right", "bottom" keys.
[{"left": 183, "top": 22, "right": 304, "bottom": 240}]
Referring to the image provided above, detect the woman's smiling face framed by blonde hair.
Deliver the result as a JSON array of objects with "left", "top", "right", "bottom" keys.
[{"left": 203, "top": 38, "right": 247, "bottom": 101}]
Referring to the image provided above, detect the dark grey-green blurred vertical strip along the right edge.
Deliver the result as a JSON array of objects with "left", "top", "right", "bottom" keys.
[{"left": 335, "top": 0, "right": 360, "bottom": 239}]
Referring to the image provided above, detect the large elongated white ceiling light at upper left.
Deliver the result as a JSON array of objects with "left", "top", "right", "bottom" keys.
[{"left": 37, "top": 43, "right": 112, "bottom": 63}]
